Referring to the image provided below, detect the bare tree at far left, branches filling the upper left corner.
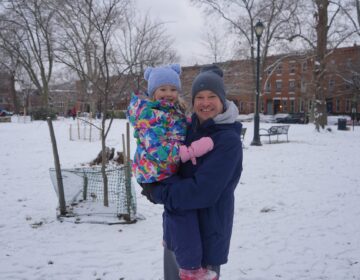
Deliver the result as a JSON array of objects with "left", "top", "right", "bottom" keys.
[{"left": 0, "top": 0, "right": 54, "bottom": 107}]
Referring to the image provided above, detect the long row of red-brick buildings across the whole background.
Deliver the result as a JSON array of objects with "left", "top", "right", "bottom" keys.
[{"left": 0, "top": 45, "right": 360, "bottom": 115}]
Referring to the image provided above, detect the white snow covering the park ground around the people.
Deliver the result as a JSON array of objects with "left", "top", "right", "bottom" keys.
[{"left": 0, "top": 119, "right": 360, "bottom": 280}]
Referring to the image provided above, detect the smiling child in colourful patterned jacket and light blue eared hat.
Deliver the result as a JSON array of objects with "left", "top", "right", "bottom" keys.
[{"left": 127, "top": 64, "right": 217, "bottom": 280}]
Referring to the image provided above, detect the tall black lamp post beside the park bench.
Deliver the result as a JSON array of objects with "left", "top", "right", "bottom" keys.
[{"left": 251, "top": 20, "right": 265, "bottom": 146}]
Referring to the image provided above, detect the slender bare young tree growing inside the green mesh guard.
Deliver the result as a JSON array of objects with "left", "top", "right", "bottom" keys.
[{"left": 53, "top": 0, "right": 129, "bottom": 206}]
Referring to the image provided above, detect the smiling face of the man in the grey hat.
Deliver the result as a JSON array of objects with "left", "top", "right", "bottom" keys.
[{"left": 194, "top": 90, "right": 224, "bottom": 123}]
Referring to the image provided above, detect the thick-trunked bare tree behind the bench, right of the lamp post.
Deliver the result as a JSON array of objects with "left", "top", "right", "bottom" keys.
[{"left": 282, "top": 0, "right": 356, "bottom": 131}]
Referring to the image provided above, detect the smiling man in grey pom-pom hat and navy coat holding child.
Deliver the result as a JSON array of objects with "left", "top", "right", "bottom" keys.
[{"left": 146, "top": 65, "right": 242, "bottom": 280}]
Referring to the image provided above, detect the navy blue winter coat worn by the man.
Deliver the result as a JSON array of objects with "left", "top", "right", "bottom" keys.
[{"left": 152, "top": 106, "right": 242, "bottom": 265}]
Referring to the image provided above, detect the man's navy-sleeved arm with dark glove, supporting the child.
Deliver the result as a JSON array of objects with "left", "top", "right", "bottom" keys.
[{"left": 151, "top": 133, "right": 242, "bottom": 210}]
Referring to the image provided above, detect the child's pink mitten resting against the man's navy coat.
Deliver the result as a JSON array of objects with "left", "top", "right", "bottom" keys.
[{"left": 179, "top": 137, "right": 214, "bottom": 165}]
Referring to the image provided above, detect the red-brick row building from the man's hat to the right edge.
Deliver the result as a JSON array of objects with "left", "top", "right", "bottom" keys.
[{"left": 182, "top": 45, "right": 360, "bottom": 115}]
